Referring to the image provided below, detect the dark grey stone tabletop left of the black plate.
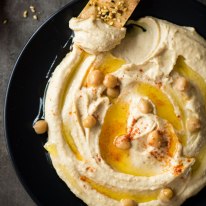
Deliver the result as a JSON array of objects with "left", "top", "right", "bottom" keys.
[{"left": 0, "top": 0, "right": 70, "bottom": 206}]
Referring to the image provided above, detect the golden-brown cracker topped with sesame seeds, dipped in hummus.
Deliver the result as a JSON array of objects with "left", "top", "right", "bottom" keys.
[{"left": 79, "top": 0, "right": 140, "bottom": 28}]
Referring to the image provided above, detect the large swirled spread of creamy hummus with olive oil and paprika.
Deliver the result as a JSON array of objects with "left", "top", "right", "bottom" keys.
[{"left": 45, "top": 17, "right": 206, "bottom": 206}]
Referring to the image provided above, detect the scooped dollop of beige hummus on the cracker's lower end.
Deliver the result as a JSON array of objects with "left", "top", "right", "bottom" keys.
[{"left": 69, "top": 17, "right": 126, "bottom": 54}]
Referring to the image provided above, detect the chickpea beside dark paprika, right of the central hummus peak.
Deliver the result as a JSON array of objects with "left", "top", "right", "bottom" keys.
[{"left": 147, "top": 130, "right": 162, "bottom": 148}]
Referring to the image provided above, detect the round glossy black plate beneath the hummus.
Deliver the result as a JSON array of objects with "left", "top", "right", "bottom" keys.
[{"left": 5, "top": 0, "right": 206, "bottom": 206}]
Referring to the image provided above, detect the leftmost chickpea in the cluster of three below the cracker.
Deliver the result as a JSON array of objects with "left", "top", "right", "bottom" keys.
[{"left": 87, "top": 70, "right": 104, "bottom": 87}]
